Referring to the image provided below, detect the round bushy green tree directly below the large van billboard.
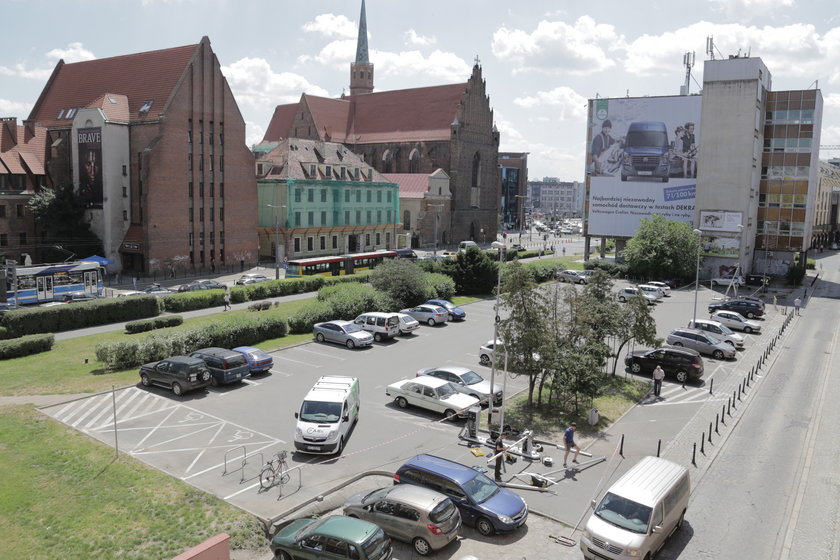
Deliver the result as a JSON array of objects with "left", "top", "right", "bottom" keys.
[{"left": 624, "top": 214, "right": 700, "bottom": 279}]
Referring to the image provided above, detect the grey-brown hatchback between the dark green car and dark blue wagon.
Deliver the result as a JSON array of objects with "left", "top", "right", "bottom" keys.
[{"left": 344, "top": 484, "right": 461, "bottom": 556}]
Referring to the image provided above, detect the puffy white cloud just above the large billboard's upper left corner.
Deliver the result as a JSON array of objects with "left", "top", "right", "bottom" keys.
[{"left": 492, "top": 16, "right": 624, "bottom": 75}]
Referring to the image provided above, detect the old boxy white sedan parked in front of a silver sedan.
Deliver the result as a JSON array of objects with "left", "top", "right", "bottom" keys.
[{"left": 385, "top": 376, "right": 478, "bottom": 421}]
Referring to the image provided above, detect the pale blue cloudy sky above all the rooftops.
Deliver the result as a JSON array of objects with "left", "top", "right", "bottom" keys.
[{"left": 0, "top": 0, "right": 840, "bottom": 181}]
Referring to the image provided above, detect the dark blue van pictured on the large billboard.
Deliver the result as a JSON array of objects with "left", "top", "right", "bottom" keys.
[{"left": 621, "top": 121, "right": 671, "bottom": 183}]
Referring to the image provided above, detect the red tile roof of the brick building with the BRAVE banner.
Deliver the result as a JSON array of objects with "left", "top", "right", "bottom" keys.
[{"left": 27, "top": 42, "right": 200, "bottom": 128}]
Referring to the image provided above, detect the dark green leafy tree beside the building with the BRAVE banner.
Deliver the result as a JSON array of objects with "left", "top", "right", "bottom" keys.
[{"left": 27, "top": 183, "right": 102, "bottom": 262}]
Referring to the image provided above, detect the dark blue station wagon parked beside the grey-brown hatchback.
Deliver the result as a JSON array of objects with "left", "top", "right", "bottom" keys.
[{"left": 394, "top": 453, "right": 528, "bottom": 537}]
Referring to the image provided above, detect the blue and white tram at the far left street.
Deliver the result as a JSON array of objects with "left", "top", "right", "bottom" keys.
[{"left": 6, "top": 261, "right": 105, "bottom": 305}]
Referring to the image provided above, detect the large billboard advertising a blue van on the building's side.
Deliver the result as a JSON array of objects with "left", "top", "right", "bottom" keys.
[{"left": 586, "top": 95, "right": 701, "bottom": 237}]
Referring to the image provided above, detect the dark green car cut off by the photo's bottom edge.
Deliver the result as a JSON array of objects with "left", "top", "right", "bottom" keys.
[{"left": 271, "top": 515, "right": 392, "bottom": 560}]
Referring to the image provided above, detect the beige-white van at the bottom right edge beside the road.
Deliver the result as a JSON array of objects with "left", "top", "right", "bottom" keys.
[{"left": 580, "top": 457, "right": 691, "bottom": 560}]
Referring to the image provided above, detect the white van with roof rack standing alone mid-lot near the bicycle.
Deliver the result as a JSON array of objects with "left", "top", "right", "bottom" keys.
[{"left": 295, "top": 375, "right": 359, "bottom": 455}]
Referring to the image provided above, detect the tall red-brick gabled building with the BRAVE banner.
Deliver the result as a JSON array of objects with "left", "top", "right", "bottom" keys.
[{"left": 25, "top": 37, "right": 257, "bottom": 273}]
